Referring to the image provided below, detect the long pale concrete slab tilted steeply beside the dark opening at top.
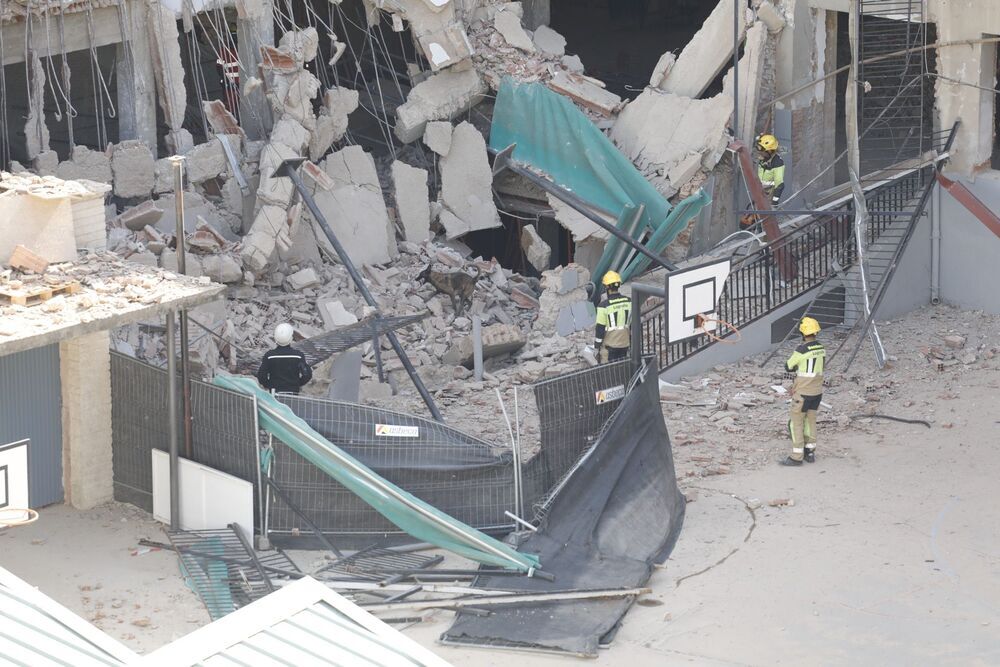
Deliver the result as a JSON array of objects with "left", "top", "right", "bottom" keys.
[{"left": 659, "top": 0, "right": 747, "bottom": 97}]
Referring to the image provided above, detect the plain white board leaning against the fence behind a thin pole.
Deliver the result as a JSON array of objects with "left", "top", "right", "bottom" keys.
[{"left": 153, "top": 449, "right": 253, "bottom": 537}]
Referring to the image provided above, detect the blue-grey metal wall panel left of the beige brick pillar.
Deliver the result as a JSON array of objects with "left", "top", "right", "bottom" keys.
[{"left": 0, "top": 345, "right": 63, "bottom": 507}]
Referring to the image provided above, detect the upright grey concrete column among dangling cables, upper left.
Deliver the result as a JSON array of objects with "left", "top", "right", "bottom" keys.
[{"left": 117, "top": 0, "right": 156, "bottom": 157}]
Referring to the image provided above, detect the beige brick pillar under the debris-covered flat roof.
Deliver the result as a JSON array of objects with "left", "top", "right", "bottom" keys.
[{"left": 59, "top": 331, "right": 114, "bottom": 509}]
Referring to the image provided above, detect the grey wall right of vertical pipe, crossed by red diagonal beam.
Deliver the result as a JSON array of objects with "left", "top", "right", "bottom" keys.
[{"left": 940, "top": 171, "right": 1000, "bottom": 314}]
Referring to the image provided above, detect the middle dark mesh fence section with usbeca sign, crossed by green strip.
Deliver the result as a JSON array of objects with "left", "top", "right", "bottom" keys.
[{"left": 268, "top": 395, "right": 514, "bottom": 548}]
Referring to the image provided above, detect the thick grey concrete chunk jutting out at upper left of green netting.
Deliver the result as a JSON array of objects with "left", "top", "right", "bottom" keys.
[{"left": 395, "top": 69, "right": 488, "bottom": 144}]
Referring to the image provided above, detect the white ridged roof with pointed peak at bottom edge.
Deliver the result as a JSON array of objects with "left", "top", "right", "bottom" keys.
[{"left": 144, "top": 578, "right": 448, "bottom": 667}]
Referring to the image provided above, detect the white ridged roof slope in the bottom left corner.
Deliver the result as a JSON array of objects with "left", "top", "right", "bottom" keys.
[{"left": 0, "top": 568, "right": 138, "bottom": 667}]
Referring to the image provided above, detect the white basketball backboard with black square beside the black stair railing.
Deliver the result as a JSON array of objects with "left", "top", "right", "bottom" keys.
[{"left": 667, "top": 259, "right": 731, "bottom": 343}]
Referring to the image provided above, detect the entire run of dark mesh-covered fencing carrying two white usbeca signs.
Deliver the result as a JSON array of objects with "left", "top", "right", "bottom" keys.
[{"left": 111, "top": 354, "right": 648, "bottom": 548}]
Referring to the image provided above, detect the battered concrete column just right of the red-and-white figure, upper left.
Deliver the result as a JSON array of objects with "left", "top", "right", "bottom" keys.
[{"left": 236, "top": 0, "right": 274, "bottom": 140}]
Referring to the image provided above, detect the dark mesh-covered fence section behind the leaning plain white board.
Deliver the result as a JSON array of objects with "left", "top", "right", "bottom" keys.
[{"left": 111, "top": 352, "right": 260, "bottom": 523}]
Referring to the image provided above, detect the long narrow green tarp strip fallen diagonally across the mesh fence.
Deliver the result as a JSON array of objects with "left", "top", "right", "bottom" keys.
[{"left": 213, "top": 374, "right": 539, "bottom": 572}]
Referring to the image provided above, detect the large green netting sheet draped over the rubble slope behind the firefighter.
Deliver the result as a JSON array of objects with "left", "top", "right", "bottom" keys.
[{"left": 490, "top": 79, "right": 711, "bottom": 280}]
